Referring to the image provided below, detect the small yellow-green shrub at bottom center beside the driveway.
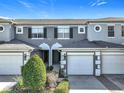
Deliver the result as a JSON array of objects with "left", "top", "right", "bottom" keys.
[{"left": 55, "top": 80, "right": 69, "bottom": 93}]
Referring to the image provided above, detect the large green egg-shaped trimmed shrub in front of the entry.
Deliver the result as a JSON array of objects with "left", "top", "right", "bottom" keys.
[{"left": 22, "top": 54, "right": 46, "bottom": 92}]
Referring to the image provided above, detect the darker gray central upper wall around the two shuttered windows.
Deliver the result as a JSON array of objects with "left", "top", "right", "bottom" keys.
[{"left": 16, "top": 27, "right": 86, "bottom": 46}]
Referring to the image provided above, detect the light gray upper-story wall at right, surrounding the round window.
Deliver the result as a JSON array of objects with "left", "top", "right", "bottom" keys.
[{"left": 87, "top": 24, "right": 124, "bottom": 44}]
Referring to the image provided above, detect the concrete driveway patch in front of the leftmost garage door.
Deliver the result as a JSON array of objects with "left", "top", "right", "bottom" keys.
[{"left": 0, "top": 76, "right": 16, "bottom": 91}]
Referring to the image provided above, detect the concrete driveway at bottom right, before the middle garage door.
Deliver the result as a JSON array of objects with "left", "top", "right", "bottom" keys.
[{"left": 69, "top": 76, "right": 124, "bottom": 93}]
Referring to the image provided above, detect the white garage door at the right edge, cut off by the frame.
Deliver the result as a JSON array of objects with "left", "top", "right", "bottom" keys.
[{"left": 102, "top": 53, "right": 124, "bottom": 74}]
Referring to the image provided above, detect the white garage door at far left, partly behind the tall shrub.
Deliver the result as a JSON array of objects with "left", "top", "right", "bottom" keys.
[{"left": 0, "top": 53, "right": 23, "bottom": 75}]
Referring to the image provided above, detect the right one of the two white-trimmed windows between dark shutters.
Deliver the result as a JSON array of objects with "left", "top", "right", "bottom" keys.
[{"left": 58, "top": 27, "right": 70, "bottom": 39}]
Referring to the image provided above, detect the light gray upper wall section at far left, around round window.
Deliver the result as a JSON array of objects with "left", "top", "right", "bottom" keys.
[{"left": 0, "top": 24, "right": 14, "bottom": 42}]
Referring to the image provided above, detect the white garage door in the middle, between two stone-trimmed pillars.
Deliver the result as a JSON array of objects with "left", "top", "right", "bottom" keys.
[{"left": 67, "top": 53, "right": 93, "bottom": 75}]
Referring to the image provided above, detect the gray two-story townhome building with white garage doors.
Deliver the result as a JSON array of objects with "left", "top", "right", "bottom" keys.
[{"left": 0, "top": 18, "right": 124, "bottom": 76}]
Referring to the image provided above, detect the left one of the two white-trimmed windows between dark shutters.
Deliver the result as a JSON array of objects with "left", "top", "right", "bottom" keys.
[{"left": 32, "top": 28, "right": 44, "bottom": 39}]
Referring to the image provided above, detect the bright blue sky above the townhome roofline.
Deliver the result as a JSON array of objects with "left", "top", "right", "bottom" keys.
[{"left": 0, "top": 0, "right": 124, "bottom": 19}]
